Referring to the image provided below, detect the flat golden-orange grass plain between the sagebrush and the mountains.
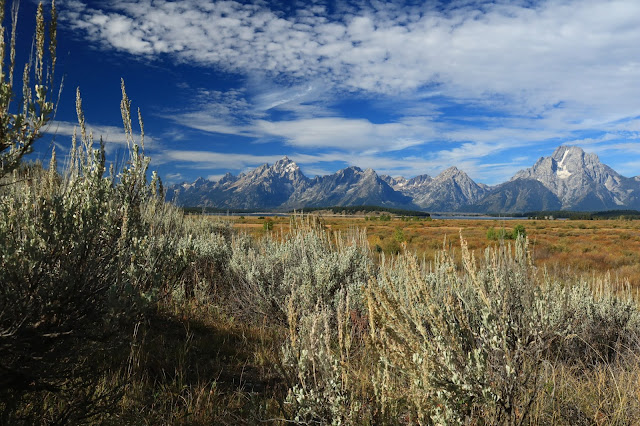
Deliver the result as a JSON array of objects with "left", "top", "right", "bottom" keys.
[{"left": 224, "top": 215, "right": 640, "bottom": 288}]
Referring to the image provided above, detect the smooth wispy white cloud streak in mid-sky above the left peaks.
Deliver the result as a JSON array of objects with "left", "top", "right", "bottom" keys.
[{"left": 162, "top": 85, "right": 435, "bottom": 151}]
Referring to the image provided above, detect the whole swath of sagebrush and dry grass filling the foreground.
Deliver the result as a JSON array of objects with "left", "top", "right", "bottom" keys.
[{"left": 0, "top": 1, "right": 640, "bottom": 425}]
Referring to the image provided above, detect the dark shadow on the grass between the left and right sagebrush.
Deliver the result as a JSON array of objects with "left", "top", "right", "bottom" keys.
[{"left": 113, "top": 306, "right": 286, "bottom": 424}]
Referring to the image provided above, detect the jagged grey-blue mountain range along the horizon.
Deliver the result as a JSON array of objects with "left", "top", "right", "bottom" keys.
[{"left": 167, "top": 146, "right": 640, "bottom": 213}]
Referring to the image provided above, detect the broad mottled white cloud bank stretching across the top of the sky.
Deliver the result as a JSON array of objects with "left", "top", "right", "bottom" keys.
[{"left": 64, "top": 0, "right": 640, "bottom": 122}]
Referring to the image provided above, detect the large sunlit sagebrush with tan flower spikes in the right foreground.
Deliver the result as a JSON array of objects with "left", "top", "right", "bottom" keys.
[{"left": 367, "top": 237, "right": 638, "bottom": 424}]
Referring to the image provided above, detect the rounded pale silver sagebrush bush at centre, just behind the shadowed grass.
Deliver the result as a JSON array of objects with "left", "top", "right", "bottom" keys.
[{"left": 230, "top": 219, "right": 373, "bottom": 323}]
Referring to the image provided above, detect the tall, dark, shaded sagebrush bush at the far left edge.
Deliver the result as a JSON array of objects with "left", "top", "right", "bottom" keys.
[{"left": 0, "top": 84, "right": 148, "bottom": 421}]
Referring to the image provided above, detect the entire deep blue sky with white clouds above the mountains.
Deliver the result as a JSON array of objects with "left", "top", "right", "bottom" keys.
[{"left": 21, "top": 0, "right": 640, "bottom": 185}]
